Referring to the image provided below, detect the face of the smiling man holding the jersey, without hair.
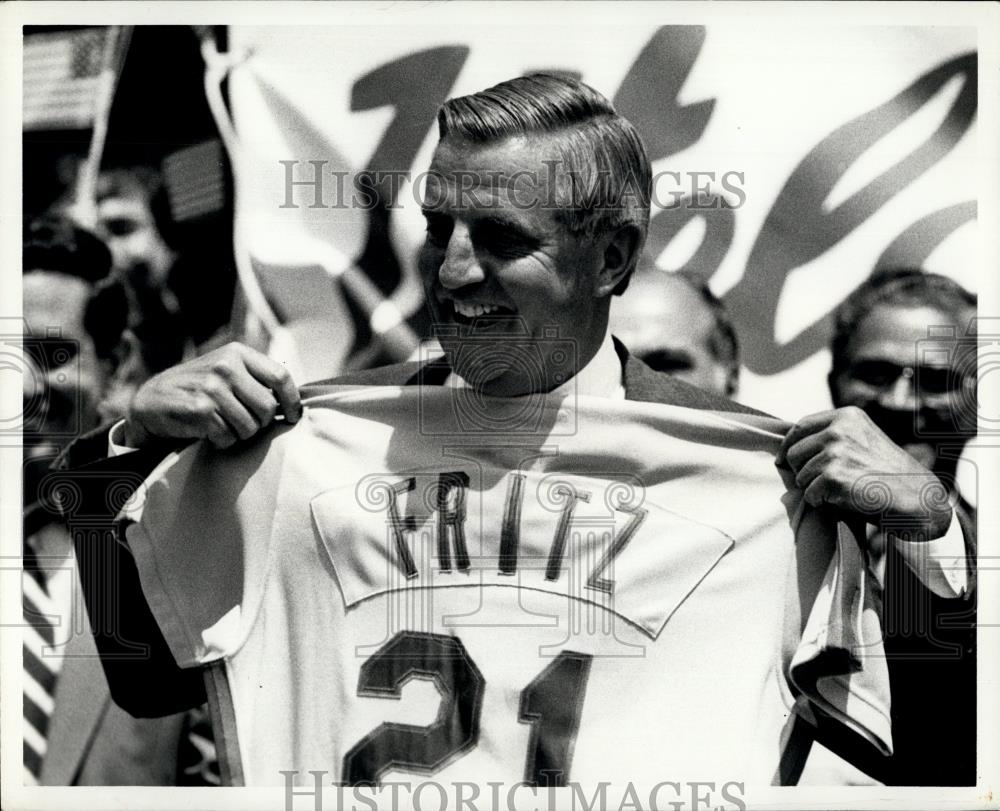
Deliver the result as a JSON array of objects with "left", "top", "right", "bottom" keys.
[{"left": 420, "top": 137, "right": 607, "bottom": 396}]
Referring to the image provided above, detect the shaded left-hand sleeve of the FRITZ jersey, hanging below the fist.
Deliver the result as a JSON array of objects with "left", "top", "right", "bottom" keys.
[{"left": 122, "top": 432, "right": 288, "bottom": 667}]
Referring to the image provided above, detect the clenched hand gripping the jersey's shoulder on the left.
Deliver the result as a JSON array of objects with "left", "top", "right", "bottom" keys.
[{"left": 125, "top": 343, "right": 302, "bottom": 448}]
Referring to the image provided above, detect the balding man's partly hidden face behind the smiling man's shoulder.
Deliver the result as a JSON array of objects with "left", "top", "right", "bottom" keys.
[{"left": 611, "top": 271, "right": 732, "bottom": 395}]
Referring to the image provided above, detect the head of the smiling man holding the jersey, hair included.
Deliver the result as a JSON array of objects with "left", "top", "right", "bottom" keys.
[{"left": 420, "top": 84, "right": 652, "bottom": 395}]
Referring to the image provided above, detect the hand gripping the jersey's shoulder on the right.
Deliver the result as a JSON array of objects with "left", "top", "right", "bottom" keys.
[{"left": 776, "top": 406, "right": 951, "bottom": 540}]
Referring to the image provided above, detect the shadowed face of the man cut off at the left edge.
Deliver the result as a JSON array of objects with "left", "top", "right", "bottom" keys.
[{"left": 22, "top": 270, "right": 106, "bottom": 464}]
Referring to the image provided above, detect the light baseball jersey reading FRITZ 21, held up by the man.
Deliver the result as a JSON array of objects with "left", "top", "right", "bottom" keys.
[{"left": 127, "top": 386, "right": 891, "bottom": 786}]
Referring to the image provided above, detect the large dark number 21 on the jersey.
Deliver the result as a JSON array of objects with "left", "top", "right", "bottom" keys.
[{"left": 341, "top": 631, "right": 593, "bottom": 786}]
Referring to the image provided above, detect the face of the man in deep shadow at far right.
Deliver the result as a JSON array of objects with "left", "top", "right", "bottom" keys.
[{"left": 830, "top": 305, "right": 974, "bottom": 470}]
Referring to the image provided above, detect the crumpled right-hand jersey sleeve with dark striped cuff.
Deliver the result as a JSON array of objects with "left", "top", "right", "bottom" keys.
[{"left": 787, "top": 508, "right": 892, "bottom": 755}]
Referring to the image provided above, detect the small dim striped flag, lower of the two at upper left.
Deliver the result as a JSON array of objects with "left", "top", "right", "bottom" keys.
[{"left": 163, "top": 139, "right": 226, "bottom": 222}]
